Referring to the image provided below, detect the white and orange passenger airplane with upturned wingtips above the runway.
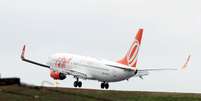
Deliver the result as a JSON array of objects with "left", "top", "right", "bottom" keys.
[{"left": 21, "top": 28, "right": 190, "bottom": 89}]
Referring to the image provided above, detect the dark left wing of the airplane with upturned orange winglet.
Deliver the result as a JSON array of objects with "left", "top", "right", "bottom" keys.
[{"left": 21, "top": 45, "right": 50, "bottom": 68}]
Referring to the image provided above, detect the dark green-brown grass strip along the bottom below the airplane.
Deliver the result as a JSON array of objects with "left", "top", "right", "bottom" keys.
[{"left": 0, "top": 85, "right": 201, "bottom": 101}]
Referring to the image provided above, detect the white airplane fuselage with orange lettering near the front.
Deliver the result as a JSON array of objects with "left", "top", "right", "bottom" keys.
[{"left": 48, "top": 54, "right": 135, "bottom": 82}]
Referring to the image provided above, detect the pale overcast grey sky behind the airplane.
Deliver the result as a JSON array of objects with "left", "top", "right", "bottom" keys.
[{"left": 0, "top": 0, "right": 201, "bottom": 92}]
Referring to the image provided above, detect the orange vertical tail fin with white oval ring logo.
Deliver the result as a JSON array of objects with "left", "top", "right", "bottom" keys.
[{"left": 117, "top": 29, "right": 143, "bottom": 67}]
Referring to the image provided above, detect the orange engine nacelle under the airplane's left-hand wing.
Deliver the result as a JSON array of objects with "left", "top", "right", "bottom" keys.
[{"left": 50, "top": 71, "right": 66, "bottom": 80}]
